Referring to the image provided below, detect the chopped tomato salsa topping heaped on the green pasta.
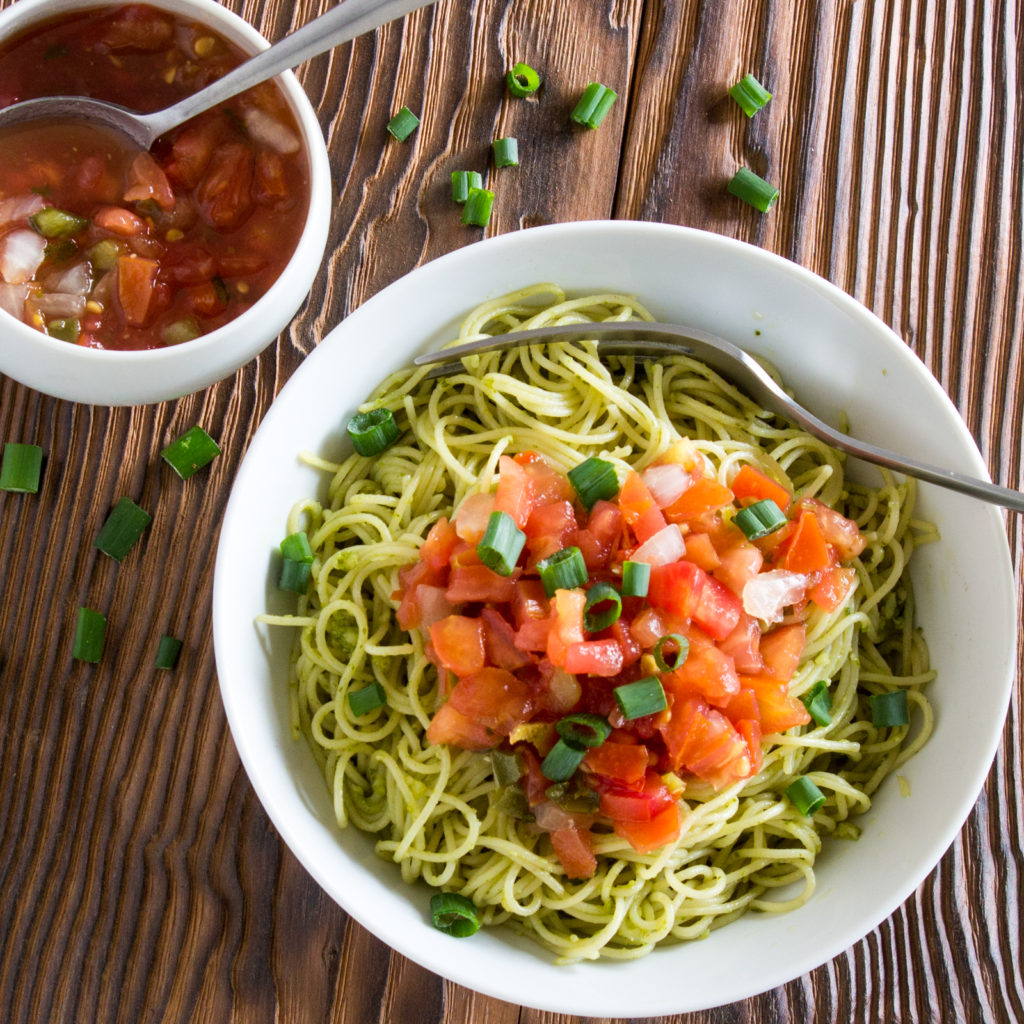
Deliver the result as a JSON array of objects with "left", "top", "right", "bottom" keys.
[{"left": 395, "top": 439, "right": 865, "bottom": 878}]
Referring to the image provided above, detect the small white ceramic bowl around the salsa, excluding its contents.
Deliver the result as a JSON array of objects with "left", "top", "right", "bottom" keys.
[{"left": 0, "top": 0, "right": 331, "bottom": 406}]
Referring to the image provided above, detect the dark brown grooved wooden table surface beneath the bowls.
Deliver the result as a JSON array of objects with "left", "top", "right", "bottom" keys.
[{"left": 0, "top": 0, "right": 1024, "bottom": 1024}]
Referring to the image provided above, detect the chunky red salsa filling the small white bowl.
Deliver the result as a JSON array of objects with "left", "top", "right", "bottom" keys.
[{"left": 0, "top": 5, "right": 309, "bottom": 349}]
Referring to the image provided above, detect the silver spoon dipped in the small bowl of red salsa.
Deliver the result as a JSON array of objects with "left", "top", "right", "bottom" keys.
[{"left": 0, "top": 0, "right": 434, "bottom": 150}]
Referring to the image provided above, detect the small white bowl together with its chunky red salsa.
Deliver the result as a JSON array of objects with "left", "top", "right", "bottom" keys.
[{"left": 0, "top": 0, "right": 330, "bottom": 404}]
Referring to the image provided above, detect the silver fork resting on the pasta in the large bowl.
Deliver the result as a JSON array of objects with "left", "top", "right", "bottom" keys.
[{"left": 413, "top": 321, "right": 1024, "bottom": 512}]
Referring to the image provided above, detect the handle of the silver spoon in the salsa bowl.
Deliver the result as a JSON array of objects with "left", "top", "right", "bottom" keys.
[{"left": 139, "top": 0, "right": 434, "bottom": 144}]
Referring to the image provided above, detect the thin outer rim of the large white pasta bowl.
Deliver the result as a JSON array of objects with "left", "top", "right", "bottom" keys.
[{"left": 213, "top": 220, "right": 1017, "bottom": 1017}]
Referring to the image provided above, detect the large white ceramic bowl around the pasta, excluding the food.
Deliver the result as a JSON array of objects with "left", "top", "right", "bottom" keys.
[{"left": 213, "top": 222, "right": 1017, "bottom": 1017}]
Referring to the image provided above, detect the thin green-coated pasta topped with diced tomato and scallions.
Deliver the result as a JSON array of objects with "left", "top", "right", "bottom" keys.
[{"left": 264, "top": 285, "right": 933, "bottom": 963}]
